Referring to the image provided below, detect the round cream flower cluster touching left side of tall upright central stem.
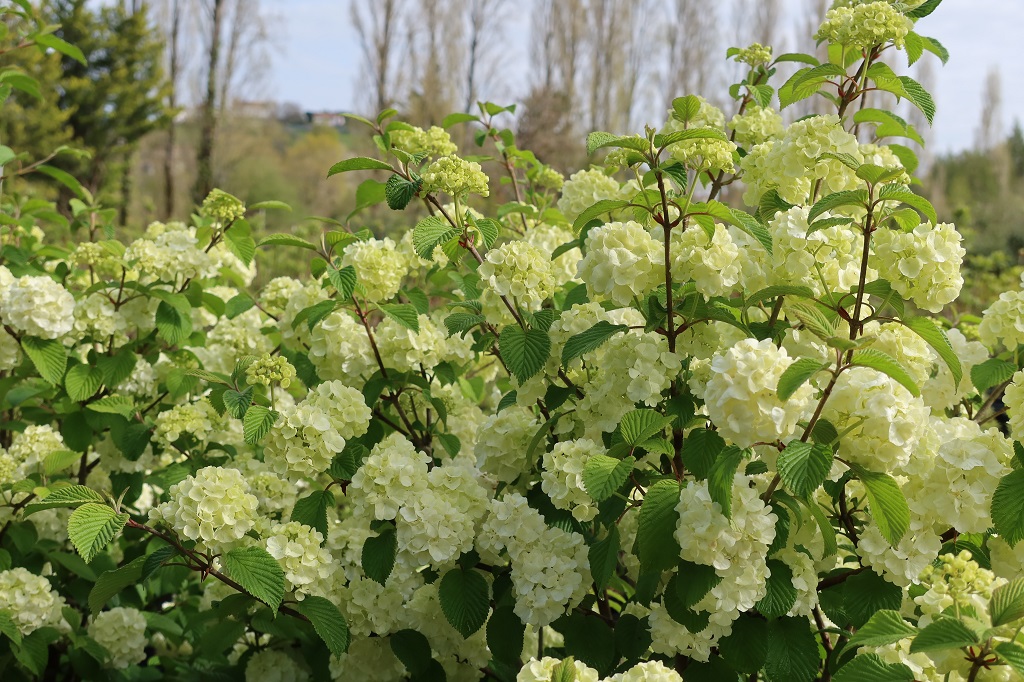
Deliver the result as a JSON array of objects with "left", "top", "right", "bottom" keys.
[{"left": 579, "top": 220, "right": 665, "bottom": 305}]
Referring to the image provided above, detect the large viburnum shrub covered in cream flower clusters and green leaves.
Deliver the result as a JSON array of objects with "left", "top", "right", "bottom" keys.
[{"left": 6, "top": 0, "right": 1024, "bottom": 682}]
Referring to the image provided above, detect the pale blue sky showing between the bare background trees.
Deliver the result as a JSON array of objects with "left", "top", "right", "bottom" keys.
[{"left": 264, "top": 0, "right": 1024, "bottom": 154}]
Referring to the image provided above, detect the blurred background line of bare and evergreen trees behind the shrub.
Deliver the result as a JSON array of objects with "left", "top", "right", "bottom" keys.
[{"left": 0, "top": 0, "right": 1024, "bottom": 298}]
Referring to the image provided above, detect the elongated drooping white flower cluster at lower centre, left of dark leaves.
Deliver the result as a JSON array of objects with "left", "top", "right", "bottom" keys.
[{"left": 477, "top": 493, "right": 592, "bottom": 627}]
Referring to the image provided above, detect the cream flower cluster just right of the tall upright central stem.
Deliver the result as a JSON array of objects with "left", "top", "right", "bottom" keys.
[{"left": 671, "top": 223, "right": 740, "bottom": 297}]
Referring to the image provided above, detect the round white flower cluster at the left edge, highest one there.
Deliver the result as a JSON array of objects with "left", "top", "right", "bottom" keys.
[{"left": 0, "top": 266, "right": 75, "bottom": 339}]
